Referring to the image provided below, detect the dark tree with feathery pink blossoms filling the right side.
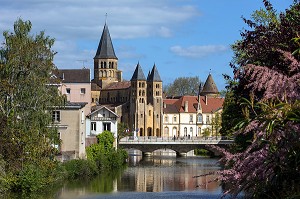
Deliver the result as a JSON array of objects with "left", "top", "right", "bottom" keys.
[{"left": 213, "top": 0, "right": 300, "bottom": 198}]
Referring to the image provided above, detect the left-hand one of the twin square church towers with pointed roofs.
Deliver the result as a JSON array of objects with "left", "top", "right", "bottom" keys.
[{"left": 130, "top": 63, "right": 147, "bottom": 136}]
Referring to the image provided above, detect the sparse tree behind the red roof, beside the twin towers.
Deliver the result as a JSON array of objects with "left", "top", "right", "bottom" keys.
[{"left": 164, "top": 76, "right": 200, "bottom": 96}]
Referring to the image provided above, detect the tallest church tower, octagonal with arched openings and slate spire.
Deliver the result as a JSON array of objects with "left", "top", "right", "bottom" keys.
[{"left": 94, "top": 23, "right": 122, "bottom": 88}]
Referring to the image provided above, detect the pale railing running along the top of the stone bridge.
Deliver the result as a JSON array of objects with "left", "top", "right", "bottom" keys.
[{"left": 120, "top": 136, "right": 233, "bottom": 142}]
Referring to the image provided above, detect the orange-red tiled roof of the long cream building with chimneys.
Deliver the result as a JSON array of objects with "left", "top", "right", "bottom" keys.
[{"left": 164, "top": 96, "right": 224, "bottom": 113}]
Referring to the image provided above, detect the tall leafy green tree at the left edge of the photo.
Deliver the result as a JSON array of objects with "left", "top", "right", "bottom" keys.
[{"left": 0, "top": 19, "right": 60, "bottom": 176}]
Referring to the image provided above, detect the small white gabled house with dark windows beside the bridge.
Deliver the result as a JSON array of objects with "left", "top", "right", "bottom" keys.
[{"left": 86, "top": 106, "right": 119, "bottom": 147}]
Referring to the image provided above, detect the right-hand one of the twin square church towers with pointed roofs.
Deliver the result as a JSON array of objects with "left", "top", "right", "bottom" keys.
[{"left": 147, "top": 64, "right": 163, "bottom": 136}]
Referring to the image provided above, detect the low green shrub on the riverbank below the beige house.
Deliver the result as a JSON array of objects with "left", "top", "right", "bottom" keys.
[{"left": 63, "top": 159, "right": 98, "bottom": 179}]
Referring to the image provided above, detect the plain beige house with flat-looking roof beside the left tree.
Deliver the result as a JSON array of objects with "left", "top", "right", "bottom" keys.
[{"left": 52, "top": 102, "right": 87, "bottom": 161}]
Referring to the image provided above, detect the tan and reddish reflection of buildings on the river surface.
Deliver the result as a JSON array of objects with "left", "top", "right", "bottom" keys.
[{"left": 118, "top": 156, "right": 219, "bottom": 192}]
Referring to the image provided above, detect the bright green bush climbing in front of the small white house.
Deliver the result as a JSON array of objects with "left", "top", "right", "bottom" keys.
[{"left": 86, "top": 131, "right": 127, "bottom": 170}]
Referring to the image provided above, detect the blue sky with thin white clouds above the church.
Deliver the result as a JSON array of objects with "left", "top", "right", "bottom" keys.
[{"left": 0, "top": 0, "right": 293, "bottom": 90}]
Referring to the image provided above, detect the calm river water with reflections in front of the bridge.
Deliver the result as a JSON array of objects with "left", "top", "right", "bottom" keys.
[{"left": 55, "top": 151, "right": 226, "bottom": 199}]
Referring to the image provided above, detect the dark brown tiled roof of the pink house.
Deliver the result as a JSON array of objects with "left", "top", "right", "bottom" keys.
[{"left": 53, "top": 68, "right": 90, "bottom": 83}]
